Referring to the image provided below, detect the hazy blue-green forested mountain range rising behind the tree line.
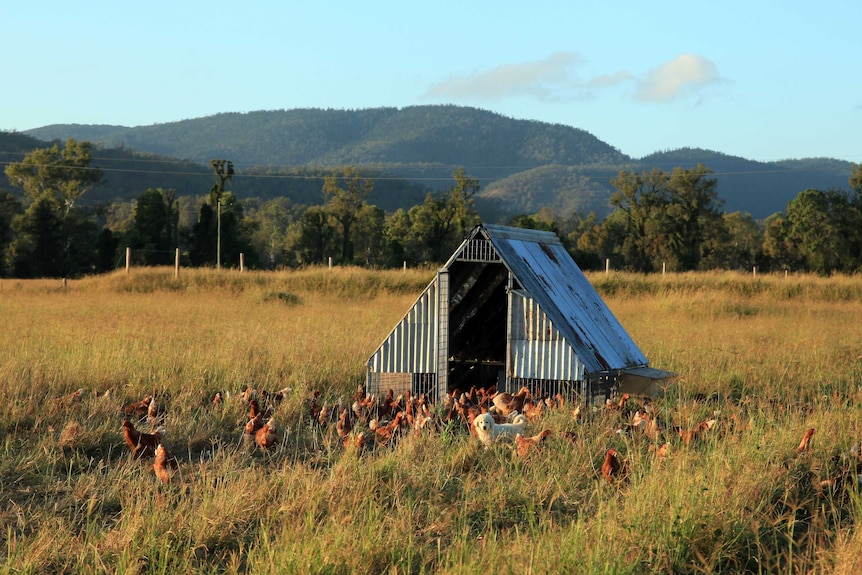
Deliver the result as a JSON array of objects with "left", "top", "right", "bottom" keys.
[{"left": 13, "top": 106, "right": 850, "bottom": 218}]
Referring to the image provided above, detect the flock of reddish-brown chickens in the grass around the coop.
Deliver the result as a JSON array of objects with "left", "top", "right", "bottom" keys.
[{"left": 54, "top": 386, "right": 862, "bottom": 493}]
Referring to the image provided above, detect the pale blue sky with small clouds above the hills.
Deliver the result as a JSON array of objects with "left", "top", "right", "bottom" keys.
[{"left": 0, "top": 0, "right": 862, "bottom": 163}]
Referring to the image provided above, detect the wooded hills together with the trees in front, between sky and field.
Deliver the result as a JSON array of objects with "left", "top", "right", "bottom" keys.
[{"left": 0, "top": 106, "right": 862, "bottom": 277}]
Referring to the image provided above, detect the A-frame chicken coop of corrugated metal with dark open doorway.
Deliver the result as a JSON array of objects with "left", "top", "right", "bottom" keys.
[{"left": 366, "top": 224, "right": 675, "bottom": 401}]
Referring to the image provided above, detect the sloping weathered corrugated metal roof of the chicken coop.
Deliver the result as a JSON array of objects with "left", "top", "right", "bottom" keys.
[{"left": 480, "top": 224, "right": 648, "bottom": 372}]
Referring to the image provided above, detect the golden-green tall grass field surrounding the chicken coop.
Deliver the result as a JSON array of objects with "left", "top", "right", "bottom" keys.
[{"left": 0, "top": 268, "right": 862, "bottom": 575}]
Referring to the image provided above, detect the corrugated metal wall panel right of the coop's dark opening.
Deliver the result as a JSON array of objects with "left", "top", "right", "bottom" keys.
[{"left": 508, "top": 291, "right": 584, "bottom": 381}]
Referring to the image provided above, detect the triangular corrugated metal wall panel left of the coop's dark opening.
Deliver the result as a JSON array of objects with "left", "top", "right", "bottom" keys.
[{"left": 368, "top": 279, "right": 438, "bottom": 373}]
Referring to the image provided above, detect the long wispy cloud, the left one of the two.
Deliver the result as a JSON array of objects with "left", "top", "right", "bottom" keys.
[{"left": 425, "top": 52, "right": 630, "bottom": 101}]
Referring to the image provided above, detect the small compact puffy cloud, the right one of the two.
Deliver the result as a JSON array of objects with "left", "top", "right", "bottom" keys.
[{"left": 635, "top": 54, "right": 722, "bottom": 102}]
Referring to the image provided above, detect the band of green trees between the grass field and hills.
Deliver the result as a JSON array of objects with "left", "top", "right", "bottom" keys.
[{"left": 5, "top": 139, "right": 862, "bottom": 278}]
